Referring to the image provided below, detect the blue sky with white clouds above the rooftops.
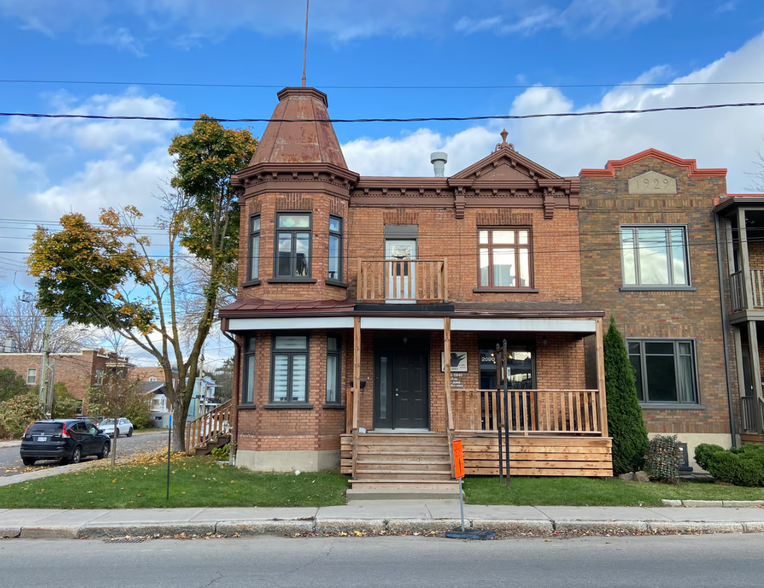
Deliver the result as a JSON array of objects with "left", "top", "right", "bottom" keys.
[{"left": 0, "top": 0, "right": 764, "bottom": 360}]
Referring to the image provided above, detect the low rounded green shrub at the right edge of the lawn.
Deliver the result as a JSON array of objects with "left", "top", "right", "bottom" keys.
[{"left": 695, "top": 444, "right": 764, "bottom": 487}]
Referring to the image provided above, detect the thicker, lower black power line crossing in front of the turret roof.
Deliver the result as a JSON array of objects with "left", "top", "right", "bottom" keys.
[{"left": 0, "top": 102, "right": 764, "bottom": 123}]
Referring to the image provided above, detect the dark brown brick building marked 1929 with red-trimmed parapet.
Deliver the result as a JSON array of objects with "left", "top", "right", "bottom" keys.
[{"left": 579, "top": 149, "right": 737, "bottom": 465}]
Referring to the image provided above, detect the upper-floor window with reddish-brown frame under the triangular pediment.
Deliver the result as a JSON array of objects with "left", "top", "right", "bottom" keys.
[{"left": 478, "top": 228, "right": 533, "bottom": 289}]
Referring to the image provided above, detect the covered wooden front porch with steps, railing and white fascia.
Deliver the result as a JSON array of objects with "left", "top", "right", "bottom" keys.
[{"left": 341, "top": 303, "right": 612, "bottom": 488}]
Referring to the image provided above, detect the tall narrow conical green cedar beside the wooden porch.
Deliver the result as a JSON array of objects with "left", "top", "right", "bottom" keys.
[{"left": 604, "top": 316, "right": 648, "bottom": 475}]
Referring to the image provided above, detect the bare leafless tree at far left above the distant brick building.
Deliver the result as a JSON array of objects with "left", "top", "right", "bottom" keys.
[{"left": 0, "top": 296, "right": 97, "bottom": 353}]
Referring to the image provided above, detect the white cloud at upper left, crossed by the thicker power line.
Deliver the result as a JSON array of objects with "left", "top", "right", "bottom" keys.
[{"left": 6, "top": 89, "right": 180, "bottom": 151}]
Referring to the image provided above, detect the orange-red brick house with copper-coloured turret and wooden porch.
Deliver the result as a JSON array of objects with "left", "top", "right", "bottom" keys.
[{"left": 220, "top": 88, "right": 612, "bottom": 490}]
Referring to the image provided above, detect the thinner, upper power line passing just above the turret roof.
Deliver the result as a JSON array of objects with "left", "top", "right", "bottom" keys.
[{"left": 0, "top": 79, "right": 764, "bottom": 90}]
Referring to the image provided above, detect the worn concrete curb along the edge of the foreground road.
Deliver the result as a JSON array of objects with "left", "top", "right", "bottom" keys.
[{"left": 0, "top": 518, "right": 764, "bottom": 540}]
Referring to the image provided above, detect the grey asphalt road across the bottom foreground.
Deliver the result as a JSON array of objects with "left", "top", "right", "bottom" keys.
[{"left": 0, "top": 534, "right": 764, "bottom": 588}]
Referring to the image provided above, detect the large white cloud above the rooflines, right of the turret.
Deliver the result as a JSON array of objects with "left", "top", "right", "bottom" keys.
[{"left": 343, "top": 35, "right": 764, "bottom": 192}]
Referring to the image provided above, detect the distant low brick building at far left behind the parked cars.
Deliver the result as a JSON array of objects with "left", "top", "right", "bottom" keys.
[{"left": 0, "top": 349, "right": 127, "bottom": 400}]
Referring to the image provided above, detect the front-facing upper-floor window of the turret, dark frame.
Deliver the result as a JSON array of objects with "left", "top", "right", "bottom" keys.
[{"left": 273, "top": 212, "right": 311, "bottom": 278}]
